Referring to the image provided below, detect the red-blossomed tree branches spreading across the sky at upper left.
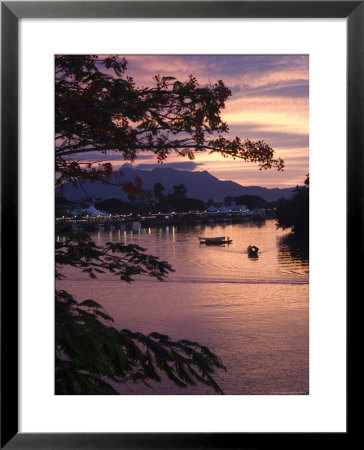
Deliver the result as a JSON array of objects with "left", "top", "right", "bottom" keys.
[{"left": 55, "top": 55, "right": 284, "bottom": 185}]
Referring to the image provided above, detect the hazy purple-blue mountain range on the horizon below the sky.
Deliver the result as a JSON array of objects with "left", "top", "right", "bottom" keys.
[{"left": 57, "top": 163, "right": 294, "bottom": 202}]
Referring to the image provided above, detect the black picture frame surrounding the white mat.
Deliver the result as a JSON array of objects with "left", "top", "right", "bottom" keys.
[{"left": 1, "top": 0, "right": 358, "bottom": 449}]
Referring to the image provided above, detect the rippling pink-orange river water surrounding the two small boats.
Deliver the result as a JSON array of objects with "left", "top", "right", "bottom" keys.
[{"left": 57, "top": 220, "right": 309, "bottom": 395}]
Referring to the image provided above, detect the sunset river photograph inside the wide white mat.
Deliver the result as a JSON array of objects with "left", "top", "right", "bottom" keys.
[{"left": 54, "top": 54, "right": 310, "bottom": 396}]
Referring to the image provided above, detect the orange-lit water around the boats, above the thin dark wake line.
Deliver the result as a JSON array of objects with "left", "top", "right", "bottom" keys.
[{"left": 57, "top": 220, "right": 309, "bottom": 284}]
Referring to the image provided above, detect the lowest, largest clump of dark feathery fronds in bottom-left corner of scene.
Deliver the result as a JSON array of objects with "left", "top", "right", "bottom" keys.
[{"left": 56, "top": 290, "right": 226, "bottom": 395}]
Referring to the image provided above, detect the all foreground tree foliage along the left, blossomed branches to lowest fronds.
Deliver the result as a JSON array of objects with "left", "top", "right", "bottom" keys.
[{"left": 55, "top": 55, "right": 284, "bottom": 394}]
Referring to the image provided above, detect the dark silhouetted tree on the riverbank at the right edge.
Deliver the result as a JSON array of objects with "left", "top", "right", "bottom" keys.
[{"left": 276, "top": 175, "right": 309, "bottom": 237}]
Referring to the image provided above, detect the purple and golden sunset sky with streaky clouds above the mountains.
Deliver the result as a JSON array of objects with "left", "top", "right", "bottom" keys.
[{"left": 104, "top": 55, "right": 309, "bottom": 188}]
